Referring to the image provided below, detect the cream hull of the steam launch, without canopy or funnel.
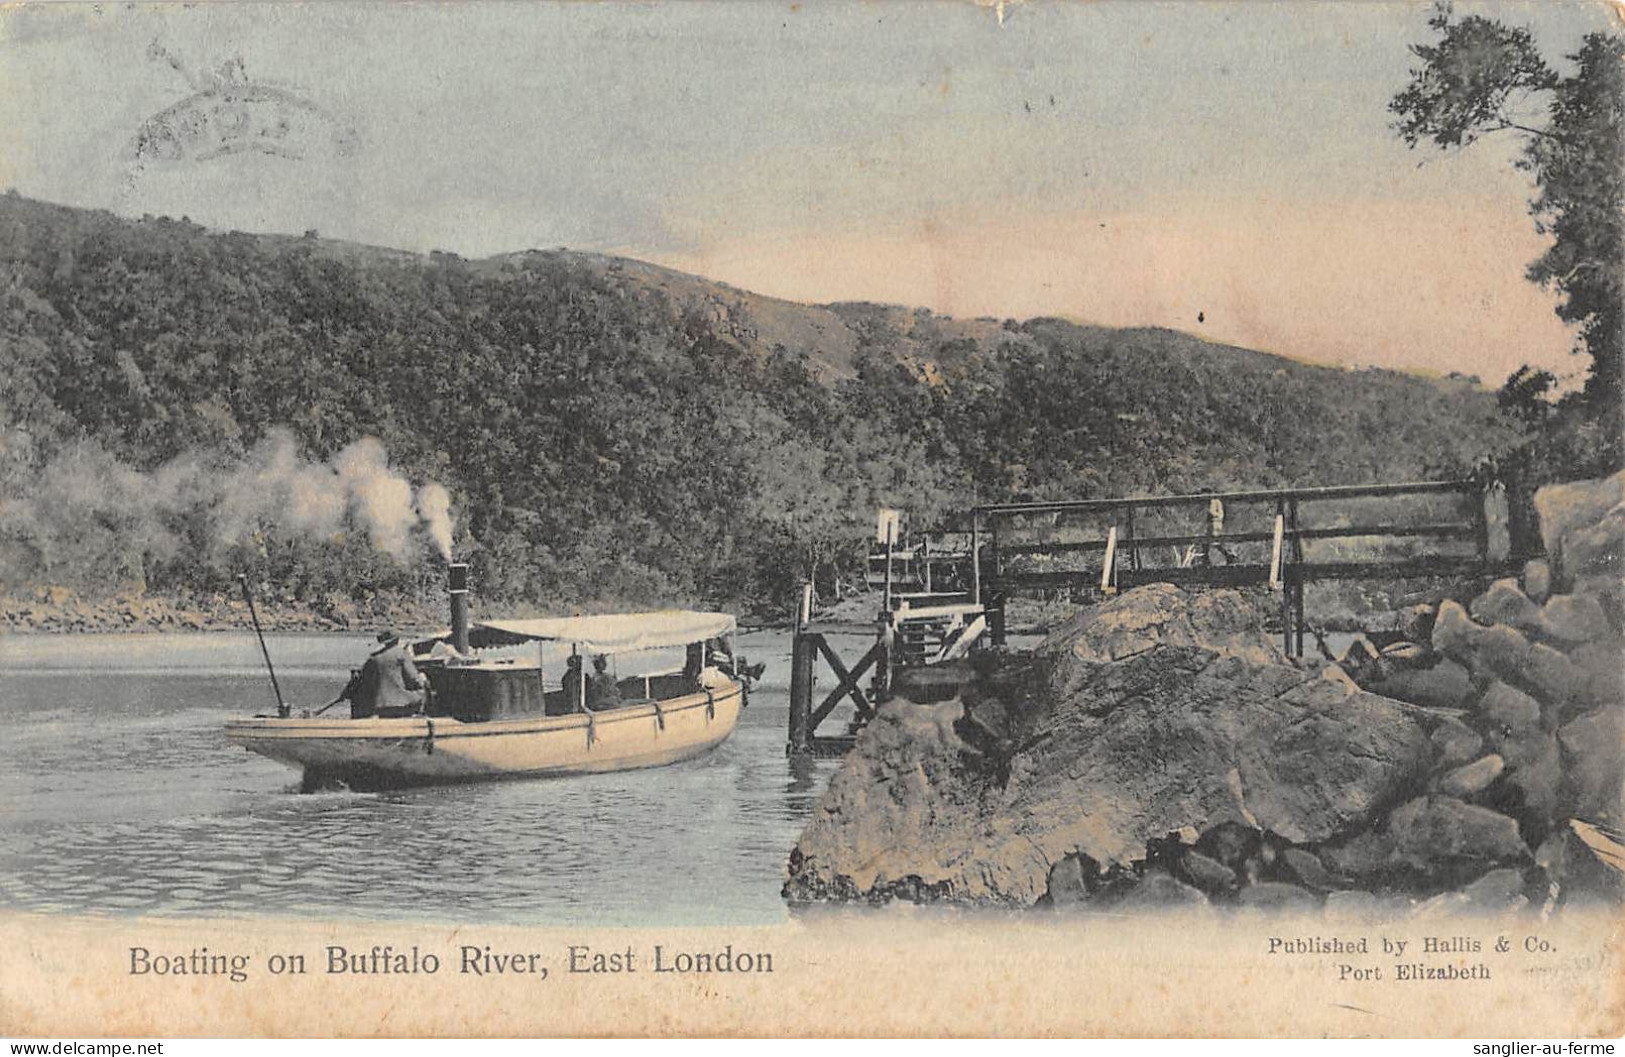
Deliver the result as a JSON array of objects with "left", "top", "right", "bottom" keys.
[{"left": 226, "top": 683, "right": 744, "bottom": 789}]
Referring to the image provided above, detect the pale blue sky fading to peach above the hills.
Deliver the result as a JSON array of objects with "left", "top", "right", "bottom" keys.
[{"left": 0, "top": 0, "right": 1620, "bottom": 385}]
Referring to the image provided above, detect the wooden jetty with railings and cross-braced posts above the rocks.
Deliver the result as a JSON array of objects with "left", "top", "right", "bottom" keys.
[{"left": 787, "top": 478, "right": 1529, "bottom": 755}]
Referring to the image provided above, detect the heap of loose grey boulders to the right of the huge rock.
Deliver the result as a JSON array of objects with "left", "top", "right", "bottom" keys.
[{"left": 1329, "top": 475, "right": 1625, "bottom": 906}]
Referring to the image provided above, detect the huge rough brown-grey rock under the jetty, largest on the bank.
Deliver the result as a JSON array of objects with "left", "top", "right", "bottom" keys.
[{"left": 785, "top": 585, "right": 1432, "bottom": 906}]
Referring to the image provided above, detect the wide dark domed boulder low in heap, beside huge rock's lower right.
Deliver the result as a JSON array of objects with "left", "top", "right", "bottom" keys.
[{"left": 1323, "top": 795, "right": 1529, "bottom": 883}]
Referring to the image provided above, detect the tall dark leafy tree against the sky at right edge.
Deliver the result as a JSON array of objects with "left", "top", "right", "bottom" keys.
[{"left": 1389, "top": 3, "right": 1625, "bottom": 473}]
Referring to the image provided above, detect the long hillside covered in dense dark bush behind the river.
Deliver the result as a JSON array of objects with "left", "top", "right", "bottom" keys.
[{"left": 0, "top": 195, "right": 1516, "bottom": 610}]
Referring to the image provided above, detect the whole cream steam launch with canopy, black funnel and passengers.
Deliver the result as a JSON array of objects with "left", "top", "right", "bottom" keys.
[{"left": 226, "top": 564, "right": 761, "bottom": 792}]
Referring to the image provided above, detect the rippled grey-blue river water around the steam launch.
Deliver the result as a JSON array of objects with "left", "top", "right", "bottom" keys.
[{"left": 0, "top": 633, "right": 850, "bottom": 925}]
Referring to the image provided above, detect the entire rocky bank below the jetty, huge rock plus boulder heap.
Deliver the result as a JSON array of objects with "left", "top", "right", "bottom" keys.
[{"left": 785, "top": 475, "right": 1625, "bottom": 916}]
